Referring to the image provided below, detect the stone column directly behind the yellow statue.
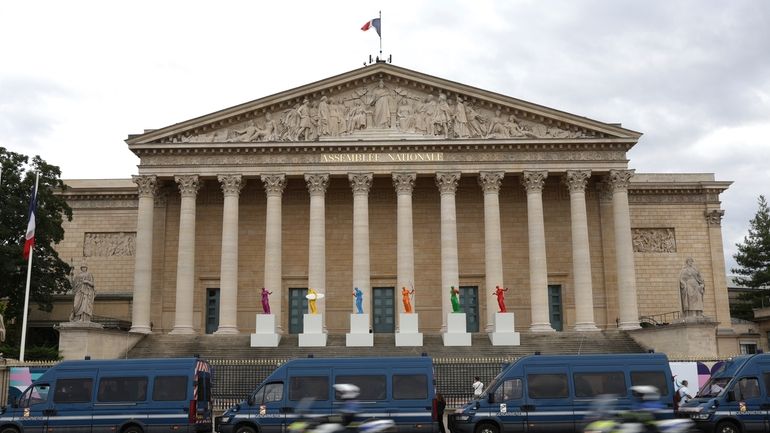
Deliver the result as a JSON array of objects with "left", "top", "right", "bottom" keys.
[{"left": 305, "top": 174, "right": 329, "bottom": 320}]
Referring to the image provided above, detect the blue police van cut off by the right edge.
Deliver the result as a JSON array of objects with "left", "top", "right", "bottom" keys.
[{"left": 679, "top": 353, "right": 770, "bottom": 433}]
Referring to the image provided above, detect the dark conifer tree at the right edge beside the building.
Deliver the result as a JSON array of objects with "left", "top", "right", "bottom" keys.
[{"left": 732, "top": 195, "right": 770, "bottom": 320}]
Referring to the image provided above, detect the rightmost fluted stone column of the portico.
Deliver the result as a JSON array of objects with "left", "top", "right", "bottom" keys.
[{"left": 608, "top": 170, "right": 640, "bottom": 329}]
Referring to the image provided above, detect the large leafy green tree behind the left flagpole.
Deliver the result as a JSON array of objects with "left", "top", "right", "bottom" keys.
[{"left": 0, "top": 147, "right": 72, "bottom": 346}]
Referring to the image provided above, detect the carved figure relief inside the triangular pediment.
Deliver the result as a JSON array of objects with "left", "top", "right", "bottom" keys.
[{"left": 169, "top": 80, "right": 586, "bottom": 143}]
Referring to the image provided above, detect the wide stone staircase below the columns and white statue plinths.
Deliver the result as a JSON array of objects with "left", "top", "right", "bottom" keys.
[{"left": 128, "top": 331, "right": 646, "bottom": 359}]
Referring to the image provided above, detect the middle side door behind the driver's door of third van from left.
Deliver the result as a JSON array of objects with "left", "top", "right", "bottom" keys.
[{"left": 523, "top": 365, "right": 575, "bottom": 433}]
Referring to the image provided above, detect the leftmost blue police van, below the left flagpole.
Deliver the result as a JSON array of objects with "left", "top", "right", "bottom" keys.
[{"left": 0, "top": 358, "right": 212, "bottom": 433}]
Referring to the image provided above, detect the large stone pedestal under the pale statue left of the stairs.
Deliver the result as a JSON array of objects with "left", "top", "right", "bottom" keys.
[{"left": 56, "top": 322, "right": 145, "bottom": 360}]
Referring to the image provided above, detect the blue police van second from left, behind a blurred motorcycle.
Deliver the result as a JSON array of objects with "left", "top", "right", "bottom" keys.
[{"left": 216, "top": 357, "right": 438, "bottom": 433}]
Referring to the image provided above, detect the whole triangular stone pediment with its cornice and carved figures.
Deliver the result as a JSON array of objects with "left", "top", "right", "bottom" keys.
[{"left": 127, "top": 63, "right": 641, "bottom": 145}]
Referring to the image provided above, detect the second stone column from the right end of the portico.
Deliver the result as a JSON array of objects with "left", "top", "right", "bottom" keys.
[{"left": 564, "top": 170, "right": 599, "bottom": 331}]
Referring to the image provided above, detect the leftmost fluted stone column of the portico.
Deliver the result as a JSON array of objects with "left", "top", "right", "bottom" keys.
[{"left": 130, "top": 176, "right": 157, "bottom": 334}]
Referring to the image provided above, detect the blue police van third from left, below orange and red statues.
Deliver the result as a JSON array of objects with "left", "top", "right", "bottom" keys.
[{"left": 448, "top": 353, "right": 674, "bottom": 433}]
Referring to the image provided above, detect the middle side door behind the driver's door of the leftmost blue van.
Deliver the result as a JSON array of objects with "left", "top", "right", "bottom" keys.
[{"left": 48, "top": 371, "right": 96, "bottom": 433}]
